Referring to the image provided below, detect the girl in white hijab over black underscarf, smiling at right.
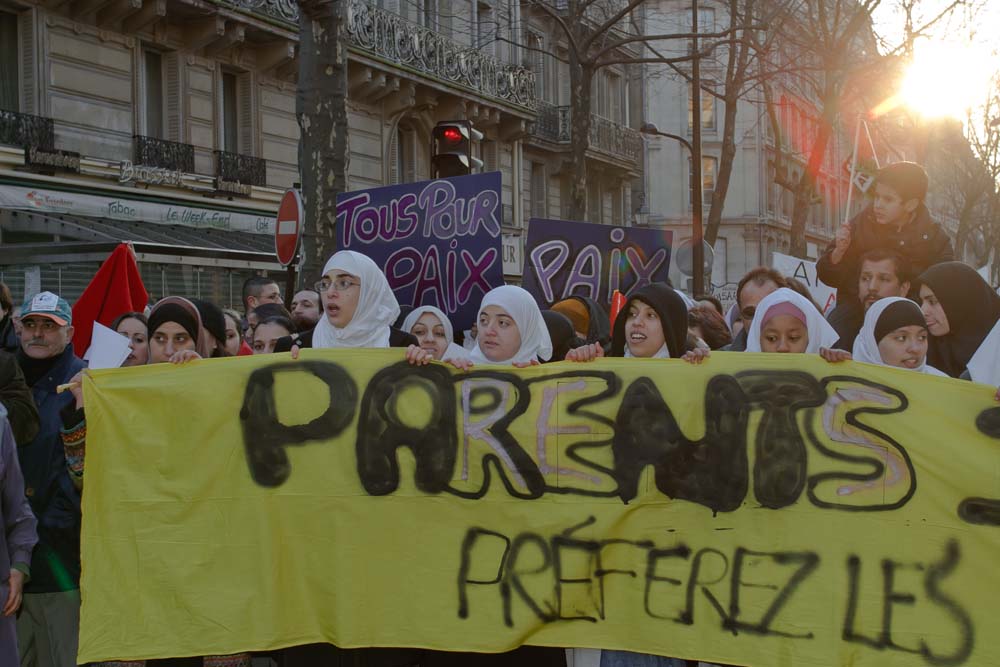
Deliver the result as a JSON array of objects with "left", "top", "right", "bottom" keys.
[{"left": 854, "top": 296, "right": 947, "bottom": 377}]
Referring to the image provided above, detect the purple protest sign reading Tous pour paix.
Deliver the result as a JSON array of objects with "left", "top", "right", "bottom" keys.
[{"left": 337, "top": 172, "right": 503, "bottom": 330}]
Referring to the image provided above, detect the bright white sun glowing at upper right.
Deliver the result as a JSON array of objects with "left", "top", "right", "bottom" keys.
[{"left": 899, "top": 42, "right": 989, "bottom": 119}]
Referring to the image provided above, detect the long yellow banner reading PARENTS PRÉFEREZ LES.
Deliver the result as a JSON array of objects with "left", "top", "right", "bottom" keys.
[{"left": 79, "top": 350, "right": 1000, "bottom": 667}]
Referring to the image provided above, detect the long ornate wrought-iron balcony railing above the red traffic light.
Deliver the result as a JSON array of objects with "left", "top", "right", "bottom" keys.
[{"left": 347, "top": 0, "right": 537, "bottom": 110}]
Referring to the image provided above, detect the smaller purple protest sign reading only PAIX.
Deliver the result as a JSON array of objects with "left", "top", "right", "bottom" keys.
[{"left": 524, "top": 218, "right": 673, "bottom": 307}]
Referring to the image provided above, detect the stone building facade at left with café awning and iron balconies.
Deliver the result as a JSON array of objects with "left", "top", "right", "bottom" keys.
[{"left": 0, "top": 0, "right": 641, "bottom": 304}]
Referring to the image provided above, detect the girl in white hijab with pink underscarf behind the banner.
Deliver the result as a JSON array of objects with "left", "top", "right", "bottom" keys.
[{"left": 746, "top": 287, "right": 850, "bottom": 361}]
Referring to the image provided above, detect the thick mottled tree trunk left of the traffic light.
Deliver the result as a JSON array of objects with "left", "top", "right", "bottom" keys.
[{"left": 296, "top": 0, "right": 350, "bottom": 284}]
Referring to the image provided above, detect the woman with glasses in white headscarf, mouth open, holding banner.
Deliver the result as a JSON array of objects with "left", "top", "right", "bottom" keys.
[{"left": 274, "top": 250, "right": 417, "bottom": 352}]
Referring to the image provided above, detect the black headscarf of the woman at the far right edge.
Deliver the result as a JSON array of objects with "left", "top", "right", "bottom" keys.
[{"left": 919, "top": 262, "right": 1000, "bottom": 378}]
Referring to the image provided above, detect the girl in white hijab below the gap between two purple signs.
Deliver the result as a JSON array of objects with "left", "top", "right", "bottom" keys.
[{"left": 462, "top": 285, "right": 552, "bottom": 368}]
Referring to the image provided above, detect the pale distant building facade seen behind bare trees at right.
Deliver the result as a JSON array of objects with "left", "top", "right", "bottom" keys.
[{"left": 641, "top": 0, "right": 884, "bottom": 296}]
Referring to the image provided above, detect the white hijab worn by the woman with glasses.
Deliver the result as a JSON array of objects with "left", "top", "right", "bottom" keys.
[{"left": 313, "top": 250, "right": 399, "bottom": 347}]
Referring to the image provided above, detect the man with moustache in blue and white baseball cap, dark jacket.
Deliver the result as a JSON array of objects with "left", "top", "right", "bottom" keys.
[{"left": 12, "top": 292, "right": 85, "bottom": 667}]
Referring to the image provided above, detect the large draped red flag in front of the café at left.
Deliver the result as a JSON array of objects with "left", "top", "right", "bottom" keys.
[{"left": 73, "top": 243, "right": 149, "bottom": 357}]
